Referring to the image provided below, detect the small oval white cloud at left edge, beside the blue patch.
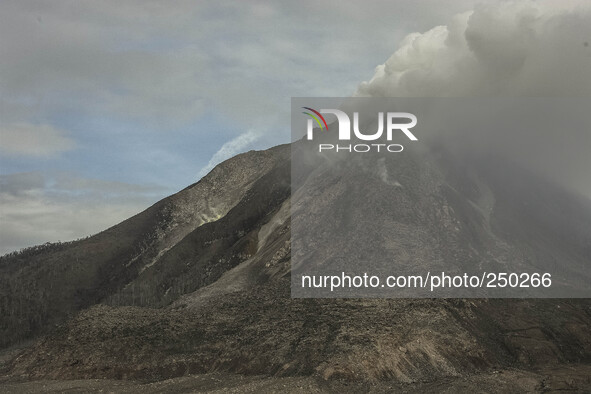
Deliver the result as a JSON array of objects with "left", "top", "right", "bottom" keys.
[{"left": 0, "top": 123, "right": 76, "bottom": 158}]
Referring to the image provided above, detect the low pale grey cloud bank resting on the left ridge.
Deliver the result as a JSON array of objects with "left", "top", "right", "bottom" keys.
[{"left": 0, "top": 172, "right": 169, "bottom": 254}]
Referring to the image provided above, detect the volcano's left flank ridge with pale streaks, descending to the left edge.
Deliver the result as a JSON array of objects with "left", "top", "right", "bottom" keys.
[{"left": 0, "top": 146, "right": 289, "bottom": 348}]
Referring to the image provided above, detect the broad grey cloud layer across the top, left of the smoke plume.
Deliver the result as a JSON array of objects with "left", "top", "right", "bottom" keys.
[{"left": 0, "top": 0, "right": 484, "bottom": 131}]
